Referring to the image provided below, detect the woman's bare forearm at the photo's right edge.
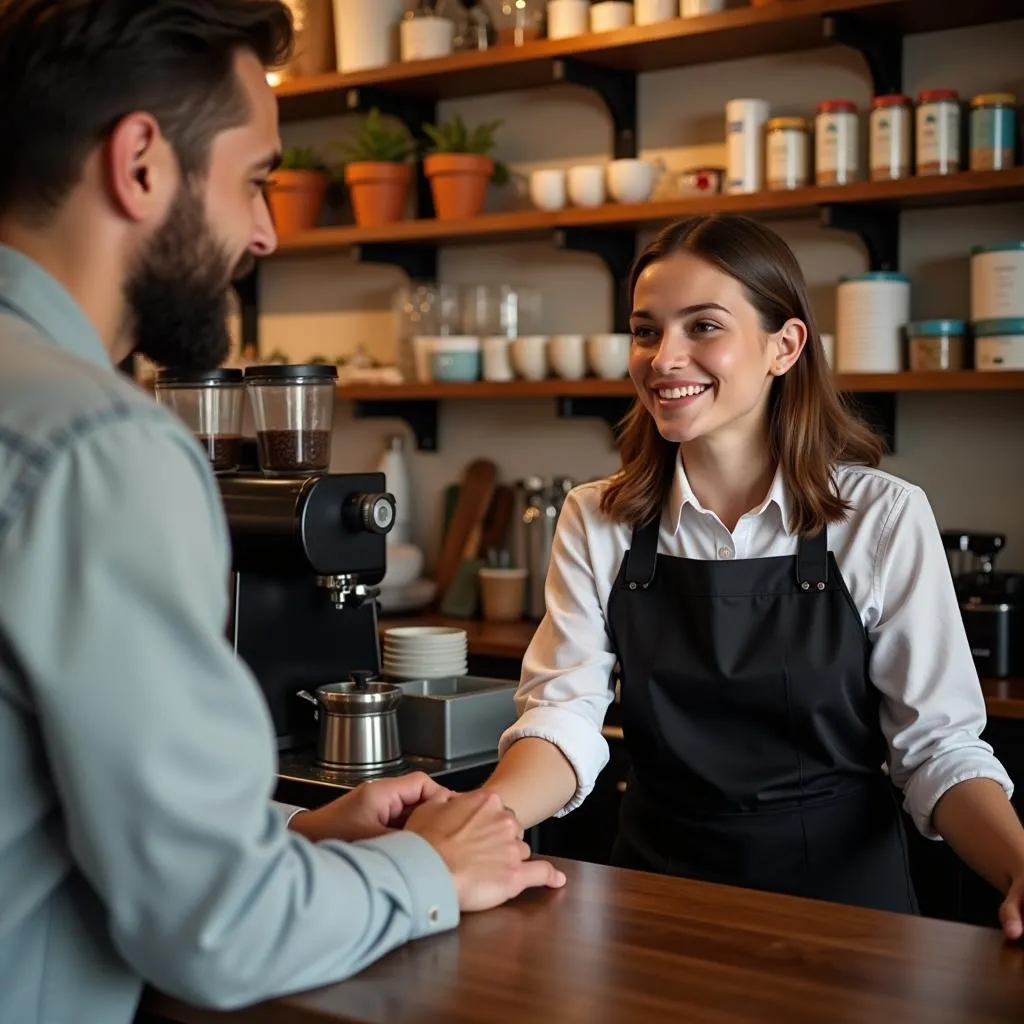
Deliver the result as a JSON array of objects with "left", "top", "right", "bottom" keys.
[{"left": 932, "top": 778, "right": 1024, "bottom": 894}]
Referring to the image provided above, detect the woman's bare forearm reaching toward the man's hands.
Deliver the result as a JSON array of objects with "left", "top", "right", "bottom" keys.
[{"left": 482, "top": 737, "right": 577, "bottom": 828}]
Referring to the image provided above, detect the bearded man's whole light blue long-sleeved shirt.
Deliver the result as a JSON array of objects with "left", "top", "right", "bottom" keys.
[{"left": 0, "top": 247, "right": 459, "bottom": 1024}]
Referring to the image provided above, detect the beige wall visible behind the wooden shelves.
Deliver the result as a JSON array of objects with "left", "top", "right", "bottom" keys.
[{"left": 261, "top": 20, "right": 1024, "bottom": 568}]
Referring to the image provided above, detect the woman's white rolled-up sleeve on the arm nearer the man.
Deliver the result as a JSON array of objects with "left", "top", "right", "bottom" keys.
[{"left": 499, "top": 493, "right": 616, "bottom": 817}]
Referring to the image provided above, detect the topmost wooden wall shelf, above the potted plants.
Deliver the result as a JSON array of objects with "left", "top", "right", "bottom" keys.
[{"left": 275, "top": 0, "right": 1024, "bottom": 120}]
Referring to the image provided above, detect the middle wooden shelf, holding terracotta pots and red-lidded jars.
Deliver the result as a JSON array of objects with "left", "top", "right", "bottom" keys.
[{"left": 278, "top": 167, "right": 1024, "bottom": 256}]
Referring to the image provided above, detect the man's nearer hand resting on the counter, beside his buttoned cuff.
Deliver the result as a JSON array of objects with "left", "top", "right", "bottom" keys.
[{"left": 406, "top": 791, "right": 565, "bottom": 911}]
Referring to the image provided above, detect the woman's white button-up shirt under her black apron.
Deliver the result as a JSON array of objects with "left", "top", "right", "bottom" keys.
[{"left": 500, "top": 462, "right": 1013, "bottom": 838}]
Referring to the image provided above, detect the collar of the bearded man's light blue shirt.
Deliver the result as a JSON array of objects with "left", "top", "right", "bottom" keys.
[{"left": 0, "top": 246, "right": 113, "bottom": 370}]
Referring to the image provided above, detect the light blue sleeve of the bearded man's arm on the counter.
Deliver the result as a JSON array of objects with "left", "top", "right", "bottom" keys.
[{"left": 0, "top": 417, "right": 459, "bottom": 1008}]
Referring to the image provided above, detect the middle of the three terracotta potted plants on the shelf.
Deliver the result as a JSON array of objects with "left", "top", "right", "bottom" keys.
[{"left": 345, "top": 106, "right": 416, "bottom": 227}]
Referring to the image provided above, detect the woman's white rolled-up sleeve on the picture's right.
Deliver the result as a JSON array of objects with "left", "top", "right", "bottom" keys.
[{"left": 869, "top": 487, "right": 1013, "bottom": 839}]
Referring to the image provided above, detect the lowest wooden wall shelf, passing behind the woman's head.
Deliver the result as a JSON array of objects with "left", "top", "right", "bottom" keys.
[{"left": 338, "top": 370, "right": 1024, "bottom": 401}]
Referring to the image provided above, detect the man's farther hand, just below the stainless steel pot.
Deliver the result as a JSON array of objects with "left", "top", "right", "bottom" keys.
[{"left": 289, "top": 772, "right": 450, "bottom": 843}]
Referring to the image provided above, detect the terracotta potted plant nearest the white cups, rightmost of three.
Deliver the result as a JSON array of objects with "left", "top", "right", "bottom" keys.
[{"left": 423, "top": 114, "right": 508, "bottom": 220}]
